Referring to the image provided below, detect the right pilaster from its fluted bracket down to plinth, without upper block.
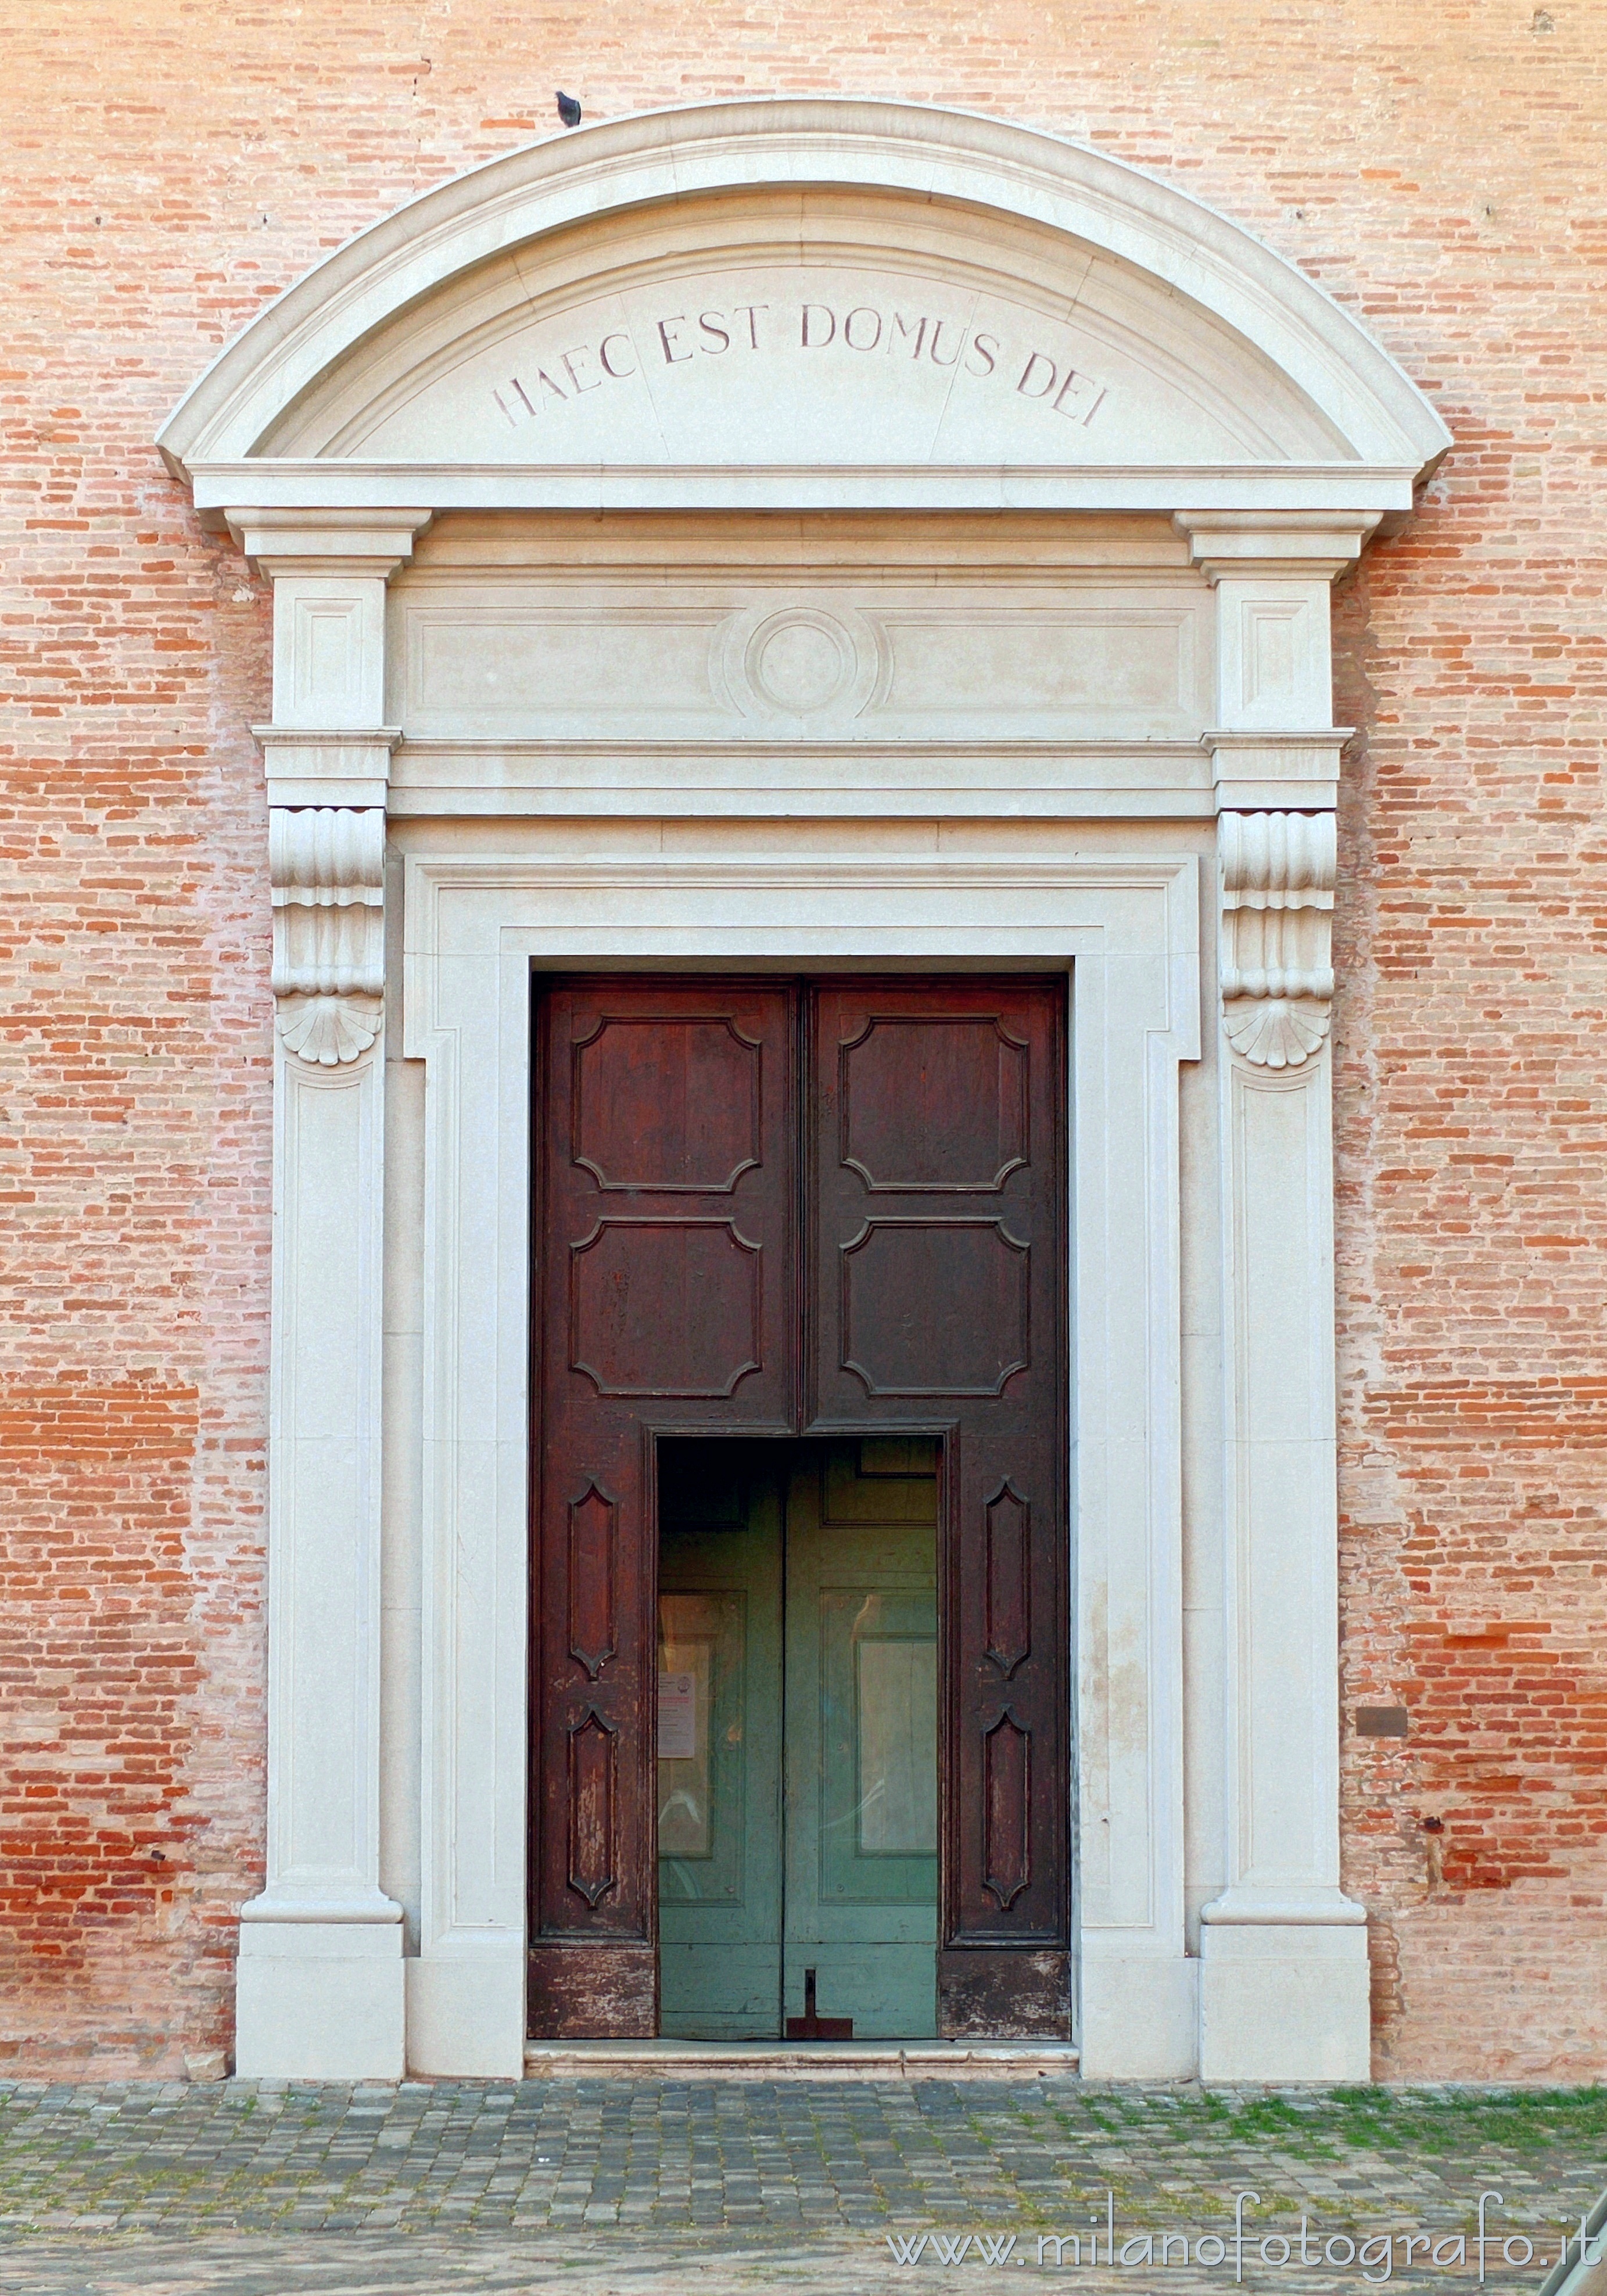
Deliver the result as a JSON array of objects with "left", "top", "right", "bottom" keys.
[{"left": 1201, "top": 813, "right": 1368, "bottom": 2080}]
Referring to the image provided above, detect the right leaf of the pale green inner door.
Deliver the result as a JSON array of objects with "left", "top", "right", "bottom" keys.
[{"left": 785, "top": 1444, "right": 939, "bottom": 2041}]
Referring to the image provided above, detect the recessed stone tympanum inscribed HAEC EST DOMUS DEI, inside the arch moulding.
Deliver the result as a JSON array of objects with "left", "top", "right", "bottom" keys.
[{"left": 229, "top": 186, "right": 1357, "bottom": 464}]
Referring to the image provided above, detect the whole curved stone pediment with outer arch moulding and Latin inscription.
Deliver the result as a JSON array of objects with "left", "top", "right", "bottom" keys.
[{"left": 161, "top": 99, "right": 1448, "bottom": 514}]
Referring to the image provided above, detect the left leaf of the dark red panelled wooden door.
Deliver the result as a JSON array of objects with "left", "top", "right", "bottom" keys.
[{"left": 530, "top": 980, "right": 797, "bottom": 2039}]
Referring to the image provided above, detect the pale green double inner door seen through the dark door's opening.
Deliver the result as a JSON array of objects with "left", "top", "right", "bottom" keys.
[{"left": 659, "top": 1438, "right": 937, "bottom": 2039}]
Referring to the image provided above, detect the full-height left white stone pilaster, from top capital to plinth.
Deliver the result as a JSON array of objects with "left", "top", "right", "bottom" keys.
[{"left": 229, "top": 512, "right": 422, "bottom": 2080}]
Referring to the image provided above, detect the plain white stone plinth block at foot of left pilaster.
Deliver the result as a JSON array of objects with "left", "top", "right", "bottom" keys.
[{"left": 234, "top": 1922, "right": 406, "bottom": 2080}]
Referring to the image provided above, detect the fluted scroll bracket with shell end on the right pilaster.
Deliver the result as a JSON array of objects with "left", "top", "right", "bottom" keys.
[{"left": 1217, "top": 813, "right": 1336, "bottom": 1068}]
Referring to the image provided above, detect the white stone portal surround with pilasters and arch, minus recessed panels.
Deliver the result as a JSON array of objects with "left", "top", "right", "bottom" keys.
[{"left": 163, "top": 101, "right": 1448, "bottom": 2080}]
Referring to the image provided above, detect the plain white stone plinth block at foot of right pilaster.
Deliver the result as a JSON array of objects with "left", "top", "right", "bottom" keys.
[{"left": 1201, "top": 1922, "right": 1373, "bottom": 2080}]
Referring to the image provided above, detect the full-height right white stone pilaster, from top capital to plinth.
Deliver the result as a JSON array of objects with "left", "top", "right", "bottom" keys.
[{"left": 1173, "top": 510, "right": 1378, "bottom": 2080}]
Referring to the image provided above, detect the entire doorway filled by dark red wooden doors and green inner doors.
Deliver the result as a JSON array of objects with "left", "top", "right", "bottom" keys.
[{"left": 528, "top": 973, "right": 1070, "bottom": 2039}]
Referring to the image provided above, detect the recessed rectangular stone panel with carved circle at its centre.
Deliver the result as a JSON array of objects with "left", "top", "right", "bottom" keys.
[{"left": 393, "top": 572, "right": 1212, "bottom": 744}]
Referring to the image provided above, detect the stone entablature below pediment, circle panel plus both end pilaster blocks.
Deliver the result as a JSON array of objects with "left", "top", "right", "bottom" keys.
[{"left": 229, "top": 505, "right": 1371, "bottom": 817}]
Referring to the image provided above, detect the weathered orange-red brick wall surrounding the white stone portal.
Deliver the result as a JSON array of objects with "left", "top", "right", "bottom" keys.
[{"left": 0, "top": 0, "right": 1607, "bottom": 2078}]
